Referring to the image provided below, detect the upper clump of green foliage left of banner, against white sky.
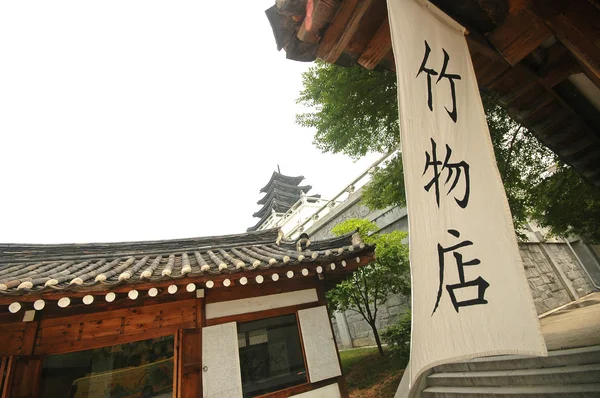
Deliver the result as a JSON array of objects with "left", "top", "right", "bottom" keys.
[{"left": 296, "top": 62, "right": 399, "bottom": 159}]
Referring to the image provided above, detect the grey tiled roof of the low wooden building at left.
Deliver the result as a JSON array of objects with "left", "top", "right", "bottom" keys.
[{"left": 0, "top": 229, "right": 373, "bottom": 294}]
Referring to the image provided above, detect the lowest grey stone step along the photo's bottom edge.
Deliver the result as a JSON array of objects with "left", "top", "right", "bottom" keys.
[{"left": 422, "top": 383, "right": 600, "bottom": 398}]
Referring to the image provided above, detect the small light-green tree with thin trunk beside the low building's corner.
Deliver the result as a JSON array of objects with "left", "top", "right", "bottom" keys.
[{"left": 327, "top": 218, "right": 410, "bottom": 356}]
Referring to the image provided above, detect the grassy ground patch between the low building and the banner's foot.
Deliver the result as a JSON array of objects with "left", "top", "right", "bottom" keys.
[{"left": 340, "top": 348, "right": 406, "bottom": 398}]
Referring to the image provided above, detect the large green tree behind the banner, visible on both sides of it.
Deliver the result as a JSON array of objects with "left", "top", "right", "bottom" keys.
[{"left": 296, "top": 62, "right": 600, "bottom": 241}]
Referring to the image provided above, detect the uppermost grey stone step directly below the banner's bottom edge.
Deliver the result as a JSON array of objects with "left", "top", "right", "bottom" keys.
[{"left": 434, "top": 346, "right": 600, "bottom": 373}]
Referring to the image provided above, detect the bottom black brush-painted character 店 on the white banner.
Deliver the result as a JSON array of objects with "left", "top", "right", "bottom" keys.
[{"left": 431, "top": 229, "right": 490, "bottom": 315}]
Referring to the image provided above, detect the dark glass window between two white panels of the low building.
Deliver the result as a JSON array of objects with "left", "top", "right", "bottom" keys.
[{"left": 238, "top": 314, "right": 308, "bottom": 397}]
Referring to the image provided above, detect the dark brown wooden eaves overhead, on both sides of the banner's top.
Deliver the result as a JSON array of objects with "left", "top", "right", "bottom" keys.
[{"left": 266, "top": 0, "right": 600, "bottom": 185}]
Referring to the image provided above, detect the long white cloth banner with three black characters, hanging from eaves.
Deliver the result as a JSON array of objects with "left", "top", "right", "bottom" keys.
[{"left": 388, "top": 0, "right": 547, "bottom": 384}]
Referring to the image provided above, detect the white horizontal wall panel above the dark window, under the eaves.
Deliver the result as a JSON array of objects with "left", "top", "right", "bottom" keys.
[{"left": 206, "top": 289, "right": 319, "bottom": 319}]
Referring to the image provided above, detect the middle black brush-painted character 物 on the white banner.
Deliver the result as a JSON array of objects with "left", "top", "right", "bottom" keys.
[{"left": 422, "top": 138, "right": 471, "bottom": 209}]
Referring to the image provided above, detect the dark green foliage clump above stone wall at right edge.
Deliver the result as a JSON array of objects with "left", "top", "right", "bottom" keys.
[{"left": 532, "top": 165, "right": 600, "bottom": 243}]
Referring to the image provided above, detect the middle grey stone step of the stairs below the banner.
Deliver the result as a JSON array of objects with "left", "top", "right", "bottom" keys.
[{"left": 427, "top": 363, "right": 600, "bottom": 387}]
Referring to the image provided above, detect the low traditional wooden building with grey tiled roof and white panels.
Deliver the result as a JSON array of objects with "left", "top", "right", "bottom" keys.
[{"left": 0, "top": 229, "right": 374, "bottom": 398}]
